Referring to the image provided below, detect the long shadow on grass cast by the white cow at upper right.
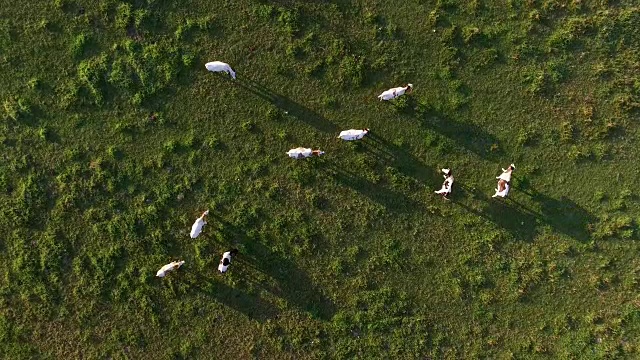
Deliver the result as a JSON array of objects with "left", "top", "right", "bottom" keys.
[{"left": 418, "top": 110, "right": 502, "bottom": 160}]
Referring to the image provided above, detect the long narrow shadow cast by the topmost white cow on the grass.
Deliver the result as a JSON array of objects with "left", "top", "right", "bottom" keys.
[{"left": 236, "top": 78, "right": 338, "bottom": 133}]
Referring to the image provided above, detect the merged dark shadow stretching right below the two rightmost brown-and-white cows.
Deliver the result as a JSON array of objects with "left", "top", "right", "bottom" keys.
[{"left": 453, "top": 183, "right": 596, "bottom": 241}]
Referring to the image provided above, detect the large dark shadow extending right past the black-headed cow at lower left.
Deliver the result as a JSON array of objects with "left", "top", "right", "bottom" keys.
[{"left": 212, "top": 214, "right": 336, "bottom": 321}]
